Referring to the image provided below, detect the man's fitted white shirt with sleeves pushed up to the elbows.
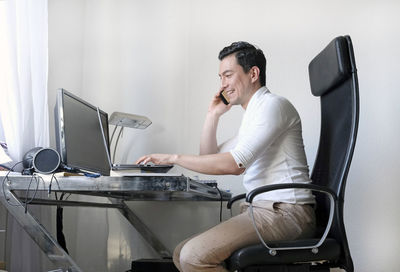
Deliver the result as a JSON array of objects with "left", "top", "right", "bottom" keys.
[{"left": 227, "top": 87, "right": 314, "bottom": 204}]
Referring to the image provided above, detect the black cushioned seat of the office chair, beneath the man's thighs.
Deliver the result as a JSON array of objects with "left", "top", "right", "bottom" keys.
[{"left": 226, "top": 238, "right": 340, "bottom": 270}]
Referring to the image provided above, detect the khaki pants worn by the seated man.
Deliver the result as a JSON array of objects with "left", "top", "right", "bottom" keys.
[{"left": 173, "top": 201, "right": 315, "bottom": 272}]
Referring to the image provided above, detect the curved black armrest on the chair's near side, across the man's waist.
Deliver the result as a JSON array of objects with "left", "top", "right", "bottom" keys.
[{"left": 246, "top": 183, "right": 337, "bottom": 203}]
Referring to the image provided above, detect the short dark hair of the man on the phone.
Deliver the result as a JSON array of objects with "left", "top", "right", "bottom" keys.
[{"left": 218, "top": 42, "right": 267, "bottom": 86}]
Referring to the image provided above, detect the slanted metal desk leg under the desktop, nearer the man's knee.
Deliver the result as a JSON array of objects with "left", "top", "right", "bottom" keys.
[{"left": 109, "top": 198, "right": 172, "bottom": 258}]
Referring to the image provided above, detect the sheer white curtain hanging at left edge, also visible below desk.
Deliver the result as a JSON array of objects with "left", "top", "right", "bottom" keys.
[{"left": 0, "top": 0, "right": 49, "bottom": 271}]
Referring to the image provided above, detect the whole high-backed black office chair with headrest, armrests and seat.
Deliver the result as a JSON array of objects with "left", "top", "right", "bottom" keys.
[{"left": 226, "top": 36, "right": 359, "bottom": 272}]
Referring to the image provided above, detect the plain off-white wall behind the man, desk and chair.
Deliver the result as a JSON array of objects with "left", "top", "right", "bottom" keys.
[{"left": 49, "top": 0, "right": 400, "bottom": 272}]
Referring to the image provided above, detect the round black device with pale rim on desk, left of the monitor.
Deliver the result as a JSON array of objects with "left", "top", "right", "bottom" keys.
[{"left": 22, "top": 147, "right": 61, "bottom": 174}]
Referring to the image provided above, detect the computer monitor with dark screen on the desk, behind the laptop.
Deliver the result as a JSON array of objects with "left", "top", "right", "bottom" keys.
[{"left": 54, "top": 89, "right": 110, "bottom": 176}]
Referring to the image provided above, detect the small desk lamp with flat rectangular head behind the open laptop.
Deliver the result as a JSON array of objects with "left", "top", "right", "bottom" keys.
[{"left": 108, "top": 112, "right": 151, "bottom": 163}]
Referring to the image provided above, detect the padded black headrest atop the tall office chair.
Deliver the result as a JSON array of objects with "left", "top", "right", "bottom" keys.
[{"left": 308, "top": 36, "right": 352, "bottom": 96}]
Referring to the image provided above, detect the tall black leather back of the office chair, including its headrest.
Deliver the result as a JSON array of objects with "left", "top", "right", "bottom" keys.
[{"left": 309, "top": 36, "right": 359, "bottom": 271}]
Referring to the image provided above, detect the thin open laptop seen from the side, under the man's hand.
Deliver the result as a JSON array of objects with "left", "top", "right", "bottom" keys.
[{"left": 97, "top": 107, "right": 173, "bottom": 173}]
